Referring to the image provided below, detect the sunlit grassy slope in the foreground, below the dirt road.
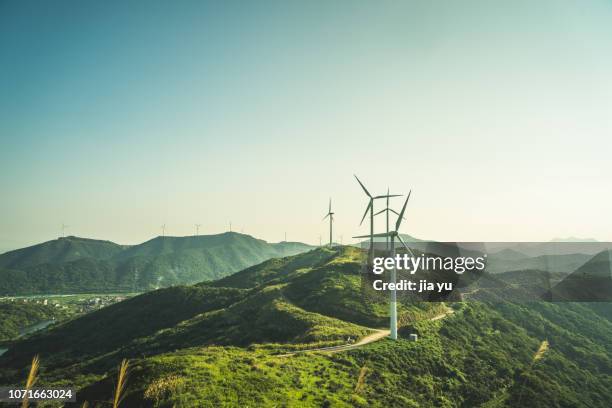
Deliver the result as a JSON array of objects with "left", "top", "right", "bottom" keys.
[{"left": 83, "top": 304, "right": 612, "bottom": 407}]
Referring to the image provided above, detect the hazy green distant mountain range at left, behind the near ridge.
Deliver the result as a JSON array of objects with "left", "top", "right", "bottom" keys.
[{"left": 0, "top": 232, "right": 313, "bottom": 295}]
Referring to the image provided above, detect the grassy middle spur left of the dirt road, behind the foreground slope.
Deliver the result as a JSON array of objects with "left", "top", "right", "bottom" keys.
[{"left": 0, "top": 245, "right": 382, "bottom": 381}]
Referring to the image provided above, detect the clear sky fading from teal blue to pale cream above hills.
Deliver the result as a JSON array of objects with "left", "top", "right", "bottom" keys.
[{"left": 0, "top": 0, "right": 612, "bottom": 251}]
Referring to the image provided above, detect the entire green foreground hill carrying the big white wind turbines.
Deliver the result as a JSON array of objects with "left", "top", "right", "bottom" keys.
[{"left": 0, "top": 247, "right": 612, "bottom": 407}]
